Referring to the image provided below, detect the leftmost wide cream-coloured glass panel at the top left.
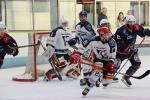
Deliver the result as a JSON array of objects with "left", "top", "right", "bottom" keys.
[{"left": 7, "top": 0, "right": 33, "bottom": 30}]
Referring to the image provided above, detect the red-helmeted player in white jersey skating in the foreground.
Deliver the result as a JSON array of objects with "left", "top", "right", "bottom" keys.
[{"left": 82, "top": 27, "right": 117, "bottom": 96}]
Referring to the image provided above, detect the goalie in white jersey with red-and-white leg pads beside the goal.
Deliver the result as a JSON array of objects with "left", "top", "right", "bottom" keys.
[{"left": 45, "top": 18, "right": 80, "bottom": 81}]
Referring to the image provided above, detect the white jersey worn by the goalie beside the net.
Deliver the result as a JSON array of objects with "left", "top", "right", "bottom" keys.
[{"left": 48, "top": 27, "right": 72, "bottom": 54}]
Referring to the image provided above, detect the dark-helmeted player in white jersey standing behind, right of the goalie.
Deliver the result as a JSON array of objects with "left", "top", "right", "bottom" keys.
[{"left": 68, "top": 11, "right": 97, "bottom": 85}]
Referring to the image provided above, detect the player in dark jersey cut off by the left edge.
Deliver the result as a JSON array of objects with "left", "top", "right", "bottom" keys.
[{"left": 0, "top": 22, "right": 18, "bottom": 68}]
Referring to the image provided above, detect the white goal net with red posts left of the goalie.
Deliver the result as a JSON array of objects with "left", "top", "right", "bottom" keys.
[{"left": 12, "top": 32, "right": 50, "bottom": 82}]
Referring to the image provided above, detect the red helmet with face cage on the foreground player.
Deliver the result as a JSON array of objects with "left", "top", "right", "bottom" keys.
[{"left": 97, "top": 27, "right": 112, "bottom": 42}]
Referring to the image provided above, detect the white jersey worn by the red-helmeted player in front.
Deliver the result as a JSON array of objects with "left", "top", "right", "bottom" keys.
[{"left": 84, "top": 37, "right": 117, "bottom": 61}]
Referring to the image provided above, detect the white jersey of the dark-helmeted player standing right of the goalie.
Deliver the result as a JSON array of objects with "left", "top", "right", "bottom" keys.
[{"left": 75, "top": 21, "right": 97, "bottom": 47}]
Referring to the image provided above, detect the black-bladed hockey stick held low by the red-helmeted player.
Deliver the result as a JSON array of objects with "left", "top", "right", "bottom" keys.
[{"left": 82, "top": 62, "right": 150, "bottom": 79}]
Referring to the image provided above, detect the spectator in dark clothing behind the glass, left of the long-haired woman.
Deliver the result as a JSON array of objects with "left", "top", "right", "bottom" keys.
[{"left": 97, "top": 8, "right": 107, "bottom": 27}]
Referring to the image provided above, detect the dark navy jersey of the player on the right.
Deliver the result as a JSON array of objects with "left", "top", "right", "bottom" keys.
[{"left": 114, "top": 24, "right": 150, "bottom": 52}]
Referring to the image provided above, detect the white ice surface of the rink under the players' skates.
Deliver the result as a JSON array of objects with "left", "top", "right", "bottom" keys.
[{"left": 0, "top": 55, "right": 150, "bottom": 100}]
